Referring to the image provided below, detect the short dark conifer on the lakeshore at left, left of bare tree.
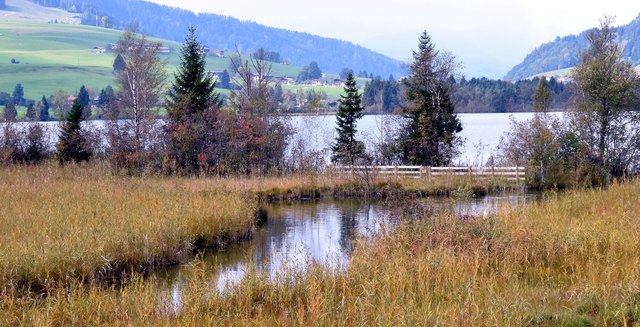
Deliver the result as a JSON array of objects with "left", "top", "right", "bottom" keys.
[{"left": 56, "top": 99, "right": 93, "bottom": 164}]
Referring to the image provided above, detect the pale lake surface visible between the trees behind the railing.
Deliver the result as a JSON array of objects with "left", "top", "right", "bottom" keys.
[{"left": 11, "top": 113, "right": 561, "bottom": 166}]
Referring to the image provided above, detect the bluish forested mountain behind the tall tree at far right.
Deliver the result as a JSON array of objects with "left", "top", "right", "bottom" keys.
[{"left": 504, "top": 15, "right": 640, "bottom": 80}]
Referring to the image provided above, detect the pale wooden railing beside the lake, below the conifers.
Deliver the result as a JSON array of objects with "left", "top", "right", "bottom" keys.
[{"left": 333, "top": 166, "right": 526, "bottom": 182}]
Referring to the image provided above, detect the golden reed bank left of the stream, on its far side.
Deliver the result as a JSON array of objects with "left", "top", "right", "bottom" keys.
[{"left": 0, "top": 165, "right": 255, "bottom": 294}]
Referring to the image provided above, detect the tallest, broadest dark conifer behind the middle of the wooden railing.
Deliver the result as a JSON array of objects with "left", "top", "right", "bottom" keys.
[{"left": 398, "top": 31, "right": 462, "bottom": 166}]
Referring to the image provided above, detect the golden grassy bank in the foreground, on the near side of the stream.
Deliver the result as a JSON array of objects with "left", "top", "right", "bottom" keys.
[{"left": 5, "top": 174, "right": 640, "bottom": 326}]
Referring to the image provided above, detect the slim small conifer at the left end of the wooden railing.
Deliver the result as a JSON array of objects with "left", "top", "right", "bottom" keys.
[{"left": 331, "top": 74, "right": 366, "bottom": 166}]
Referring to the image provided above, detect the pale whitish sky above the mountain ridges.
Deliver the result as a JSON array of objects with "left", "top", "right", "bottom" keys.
[{"left": 151, "top": 0, "right": 640, "bottom": 78}]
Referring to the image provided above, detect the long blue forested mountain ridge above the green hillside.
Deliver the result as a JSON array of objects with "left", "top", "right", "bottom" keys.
[{"left": 31, "top": 0, "right": 405, "bottom": 77}]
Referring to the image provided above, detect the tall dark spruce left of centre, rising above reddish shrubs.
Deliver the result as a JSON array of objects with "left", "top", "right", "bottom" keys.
[{"left": 166, "top": 26, "right": 222, "bottom": 174}]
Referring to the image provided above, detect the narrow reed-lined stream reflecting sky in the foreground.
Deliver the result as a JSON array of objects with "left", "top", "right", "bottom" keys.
[{"left": 159, "top": 193, "right": 541, "bottom": 307}]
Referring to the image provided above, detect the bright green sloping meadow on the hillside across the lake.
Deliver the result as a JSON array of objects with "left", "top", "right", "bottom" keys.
[{"left": 0, "top": 19, "right": 300, "bottom": 99}]
